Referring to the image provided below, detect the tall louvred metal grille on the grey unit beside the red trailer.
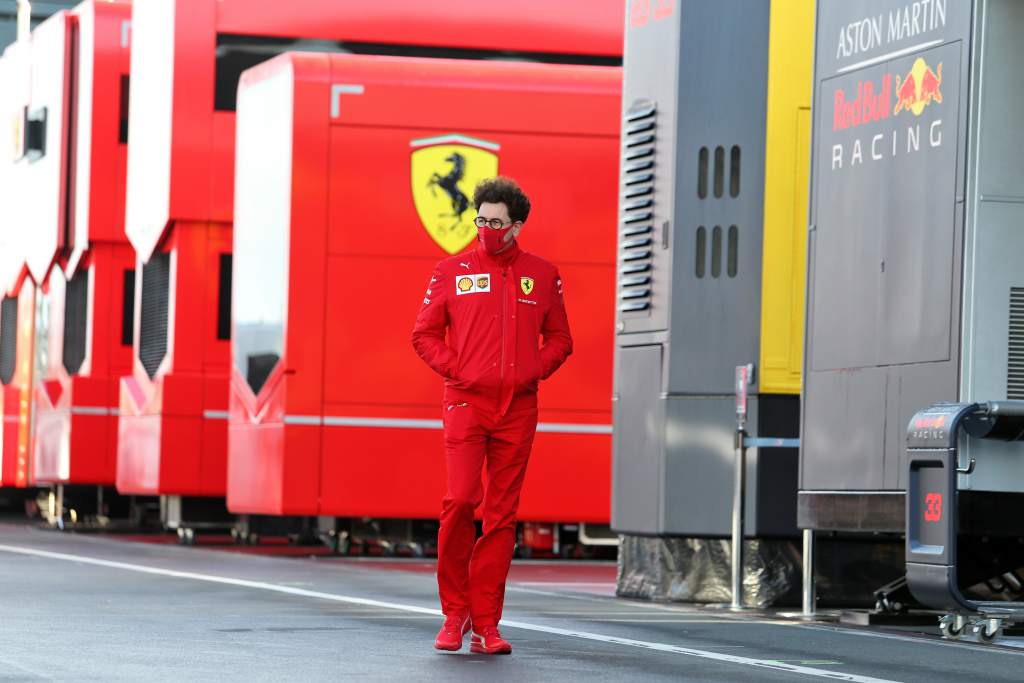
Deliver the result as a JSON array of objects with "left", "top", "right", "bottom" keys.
[{"left": 617, "top": 99, "right": 657, "bottom": 312}]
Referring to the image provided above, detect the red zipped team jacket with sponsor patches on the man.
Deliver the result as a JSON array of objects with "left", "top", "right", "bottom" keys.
[{"left": 413, "top": 244, "right": 572, "bottom": 415}]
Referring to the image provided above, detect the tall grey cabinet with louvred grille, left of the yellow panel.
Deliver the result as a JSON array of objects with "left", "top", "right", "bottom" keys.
[{"left": 611, "top": 0, "right": 798, "bottom": 537}]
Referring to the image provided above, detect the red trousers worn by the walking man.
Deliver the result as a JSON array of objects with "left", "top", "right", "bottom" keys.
[{"left": 437, "top": 395, "right": 537, "bottom": 627}]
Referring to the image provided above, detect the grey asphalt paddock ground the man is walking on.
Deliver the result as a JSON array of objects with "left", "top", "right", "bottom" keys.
[{"left": 0, "top": 524, "right": 1024, "bottom": 683}]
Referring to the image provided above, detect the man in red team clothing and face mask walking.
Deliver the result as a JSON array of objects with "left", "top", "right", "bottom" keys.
[{"left": 413, "top": 177, "right": 572, "bottom": 654}]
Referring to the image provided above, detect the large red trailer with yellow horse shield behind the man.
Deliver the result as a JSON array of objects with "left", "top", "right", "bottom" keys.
[{"left": 228, "top": 54, "right": 622, "bottom": 522}]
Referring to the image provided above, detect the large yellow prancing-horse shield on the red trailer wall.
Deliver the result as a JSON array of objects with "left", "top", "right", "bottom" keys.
[{"left": 410, "top": 134, "right": 501, "bottom": 254}]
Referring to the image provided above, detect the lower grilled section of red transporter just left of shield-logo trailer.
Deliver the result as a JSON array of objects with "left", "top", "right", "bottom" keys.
[{"left": 117, "top": 224, "right": 231, "bottom": 496}]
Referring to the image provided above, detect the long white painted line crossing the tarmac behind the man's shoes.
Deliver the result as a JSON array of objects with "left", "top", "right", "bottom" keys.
[{"left": 0, "top": 545, "right": 895, "bottom": 683}]
